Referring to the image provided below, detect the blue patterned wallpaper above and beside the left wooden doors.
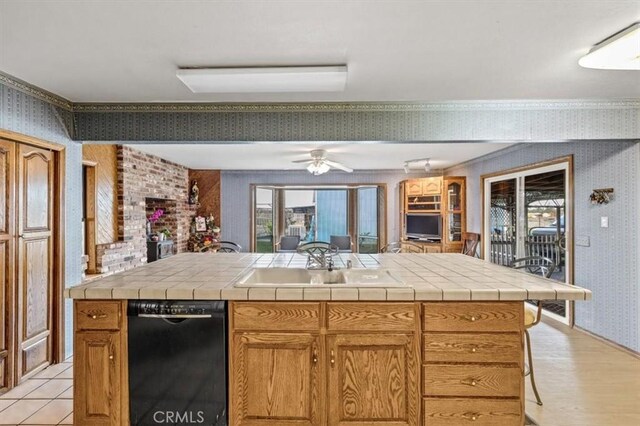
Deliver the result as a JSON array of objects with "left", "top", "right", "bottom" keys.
[{"left": 0, "top": 84, "right": 82, "bottom": 355}]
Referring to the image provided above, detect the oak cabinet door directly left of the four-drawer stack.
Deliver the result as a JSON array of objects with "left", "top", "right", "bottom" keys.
[{"left": 327, "top": 334, "right": 420, "bottom": 426}]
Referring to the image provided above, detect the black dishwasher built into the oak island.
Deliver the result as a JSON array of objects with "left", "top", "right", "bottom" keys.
[{"left": 127, "top": 300, "right": 227, "bottom": 426}]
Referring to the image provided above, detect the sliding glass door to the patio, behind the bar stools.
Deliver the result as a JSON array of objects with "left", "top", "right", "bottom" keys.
[{"left": 483, "top": 162, "right": 573, "bottom": 323}]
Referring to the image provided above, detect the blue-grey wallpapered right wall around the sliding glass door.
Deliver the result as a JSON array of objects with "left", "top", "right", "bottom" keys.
[{"left": 446, "top": 141, "right": 640, "bottom": 351}]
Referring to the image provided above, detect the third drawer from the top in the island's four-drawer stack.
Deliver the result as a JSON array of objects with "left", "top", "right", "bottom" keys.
[{"left": 422, "top": 364, "right": 522, "bottom": 397}]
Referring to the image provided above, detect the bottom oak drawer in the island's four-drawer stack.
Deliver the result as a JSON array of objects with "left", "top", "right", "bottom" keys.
[{"left": 424, "top": 398, "right": 524, "bottom": 426}]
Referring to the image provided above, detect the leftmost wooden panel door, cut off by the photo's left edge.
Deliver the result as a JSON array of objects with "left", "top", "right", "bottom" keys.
[{"left": 0, "top": 140, "right": 15, "bottom": 393}]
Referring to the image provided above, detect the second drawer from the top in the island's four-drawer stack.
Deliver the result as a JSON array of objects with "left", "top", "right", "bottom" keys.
[{"left": 422, "top": 333, "right": 523, "bottom": 364}]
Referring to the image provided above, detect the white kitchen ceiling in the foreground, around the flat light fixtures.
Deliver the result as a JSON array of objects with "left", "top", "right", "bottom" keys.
[{"left": 0, "top": 0, "right": 640, "bottom": 102}]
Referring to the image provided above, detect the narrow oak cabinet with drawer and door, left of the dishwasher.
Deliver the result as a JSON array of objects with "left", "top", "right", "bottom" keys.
[{"left": 73, "top": 300, "right": 129, "bottom": 426}]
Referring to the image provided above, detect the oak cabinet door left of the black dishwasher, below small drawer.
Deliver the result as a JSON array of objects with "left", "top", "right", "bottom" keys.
[{"left": 73, "top": 331, "right": 126, "bottom": 426}]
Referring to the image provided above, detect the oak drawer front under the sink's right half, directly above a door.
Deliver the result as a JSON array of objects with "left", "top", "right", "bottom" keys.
[{"left": 327, "top": 302, "right": 417, "bottom": 332}]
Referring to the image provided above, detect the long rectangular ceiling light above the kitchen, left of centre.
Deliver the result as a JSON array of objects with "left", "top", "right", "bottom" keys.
[{"left": 176, "top": 65, "right": 347, "bottom": 93}]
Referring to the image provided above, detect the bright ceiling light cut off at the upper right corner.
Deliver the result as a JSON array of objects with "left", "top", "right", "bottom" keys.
[{"left": 578, "top": 23, "right": 640, "bottom": 70}]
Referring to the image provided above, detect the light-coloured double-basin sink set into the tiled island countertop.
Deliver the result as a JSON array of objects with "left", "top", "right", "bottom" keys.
[{"left": 233, "top": 268, "right": 406, "bottom": 287}]
